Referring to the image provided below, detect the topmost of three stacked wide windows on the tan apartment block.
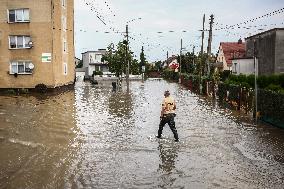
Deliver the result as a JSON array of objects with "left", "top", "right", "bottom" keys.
[{"left": 8, "top": 9, "right": 30, "bottom": 23}]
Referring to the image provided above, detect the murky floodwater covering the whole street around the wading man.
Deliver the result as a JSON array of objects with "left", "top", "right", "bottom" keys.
[{"left": 0, "top": 80, "right": 284, "bottom": 189}]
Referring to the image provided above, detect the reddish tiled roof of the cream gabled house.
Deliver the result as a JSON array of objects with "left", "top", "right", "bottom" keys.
[{"left": 220, "top": 42, "right": 246, "bottom": 66}]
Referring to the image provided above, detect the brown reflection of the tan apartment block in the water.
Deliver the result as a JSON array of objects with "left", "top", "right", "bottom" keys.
[{"left": 0, "top": 91, "right": 77, "bottom": 188}]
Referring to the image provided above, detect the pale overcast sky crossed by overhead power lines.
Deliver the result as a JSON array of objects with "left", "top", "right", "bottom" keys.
[{"left": 74, "top": 0, "right": 284, "bottom": 62}]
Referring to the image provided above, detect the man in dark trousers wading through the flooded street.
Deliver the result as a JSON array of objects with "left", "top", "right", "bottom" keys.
[{"left": 157, "top": 91, "right": 179, "bottom": 142}]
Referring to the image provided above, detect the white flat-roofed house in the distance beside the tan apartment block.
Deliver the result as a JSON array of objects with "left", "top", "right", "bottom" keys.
[{"left": 82, "top": 49, "right": 109, "bottom": 77}]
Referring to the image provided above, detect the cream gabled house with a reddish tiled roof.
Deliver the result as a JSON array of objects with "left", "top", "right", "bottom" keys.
[{"left": 214, "top": 39, "right": 245, "bottom": 71}]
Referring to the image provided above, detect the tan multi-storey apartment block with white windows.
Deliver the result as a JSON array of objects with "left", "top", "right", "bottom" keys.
[{"left": 0, "top": 0, "right": 75, "bottom": 88}]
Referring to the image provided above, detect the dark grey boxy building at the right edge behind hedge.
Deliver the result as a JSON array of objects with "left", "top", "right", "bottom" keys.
[{"left": 245, "top": 28, "right": 284, "bottom": 75}]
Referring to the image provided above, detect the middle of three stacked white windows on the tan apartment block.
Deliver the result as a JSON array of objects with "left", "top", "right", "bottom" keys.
[{"left": 9, "top": 35, "right": 31, "bottom": 49}]
